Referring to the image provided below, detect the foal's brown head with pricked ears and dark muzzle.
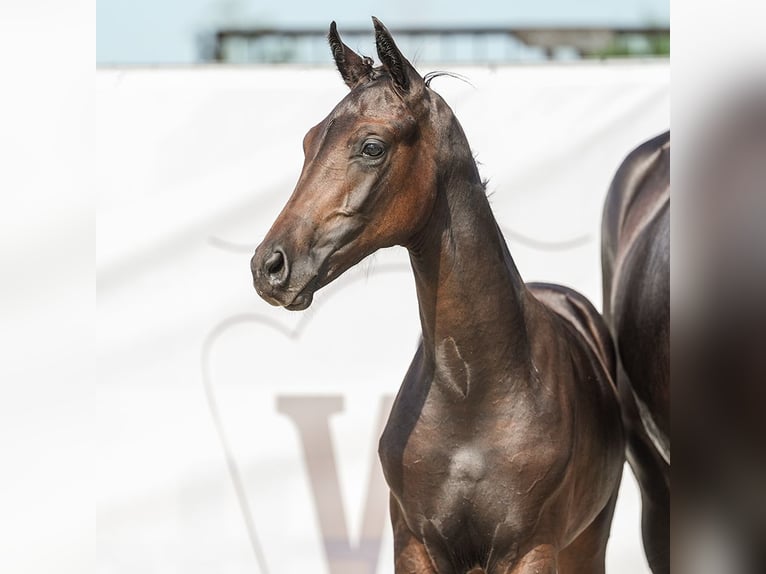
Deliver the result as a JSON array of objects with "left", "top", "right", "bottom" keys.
[{"left": 251, "top": 18, "right": 451, "bottom": 310}]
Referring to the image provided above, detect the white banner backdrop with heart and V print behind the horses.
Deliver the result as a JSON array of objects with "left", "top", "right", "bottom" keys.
[{"left": 95, "top": 62, "right": 670, "bottom": 574}]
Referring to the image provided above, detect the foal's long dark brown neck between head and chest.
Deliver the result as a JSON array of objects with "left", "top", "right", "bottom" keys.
[{"left": 409, "top": 109, "right": 531, "bottom": 398}]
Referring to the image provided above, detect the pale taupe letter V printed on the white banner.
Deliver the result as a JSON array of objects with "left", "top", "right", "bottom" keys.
[{"left": 277, "top": 395, "right": 393, "bottom": 574}]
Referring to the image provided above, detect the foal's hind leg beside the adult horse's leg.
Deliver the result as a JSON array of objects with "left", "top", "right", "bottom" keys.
[{"left": 559, "top": 482, "right": 620, "bottom": 574}]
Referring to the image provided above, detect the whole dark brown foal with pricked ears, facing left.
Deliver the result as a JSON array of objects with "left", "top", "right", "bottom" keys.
[{"left": 251, "top": 18, "right": 624, "bottom": 574}]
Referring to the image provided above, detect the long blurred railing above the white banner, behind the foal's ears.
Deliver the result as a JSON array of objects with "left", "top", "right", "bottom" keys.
[{"left": 201, "top": 26, "right": 670, "bottom": 64}]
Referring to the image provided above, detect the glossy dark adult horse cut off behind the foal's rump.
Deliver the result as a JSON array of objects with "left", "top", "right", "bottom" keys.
[{"left": 602, "top": 132, "right": 670, "bottom": 574}]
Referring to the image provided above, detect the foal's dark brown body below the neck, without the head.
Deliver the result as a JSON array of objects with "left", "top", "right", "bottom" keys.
[{"left": 380, "top": 285, "right": 621, "bottom": 573}]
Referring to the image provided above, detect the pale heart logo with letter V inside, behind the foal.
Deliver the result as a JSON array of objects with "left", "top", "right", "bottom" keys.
[{"left": 202, "top": 263, "right": 419, "bottom": 574}]
